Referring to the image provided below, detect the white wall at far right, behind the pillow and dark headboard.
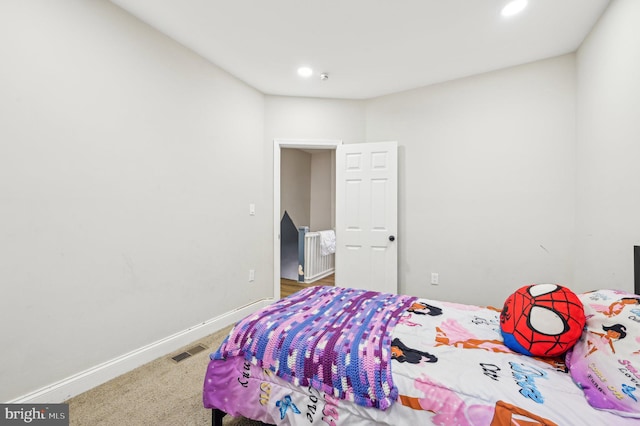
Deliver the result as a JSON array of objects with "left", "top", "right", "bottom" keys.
[{"left": 575, "top": 0, "right": 640, "bottom": 291}]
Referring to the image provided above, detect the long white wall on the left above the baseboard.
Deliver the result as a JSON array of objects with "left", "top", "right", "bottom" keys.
[{"left": 0, "top": 0, "right": 273, "bottom": 401}]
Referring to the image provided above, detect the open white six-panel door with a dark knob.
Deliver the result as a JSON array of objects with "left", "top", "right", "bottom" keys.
[{"left": 336, "top": 142, "right": 398, "bottom": 293}]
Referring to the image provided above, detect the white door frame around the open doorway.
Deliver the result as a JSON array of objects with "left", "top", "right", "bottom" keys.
[{"left": 273, "top": 139, "right": 342, "bottom": 300}]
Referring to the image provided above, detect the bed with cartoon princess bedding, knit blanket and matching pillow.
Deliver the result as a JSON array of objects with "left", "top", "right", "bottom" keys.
[{"left": 203, "top": 286, "right": 640, "bottom": 426}]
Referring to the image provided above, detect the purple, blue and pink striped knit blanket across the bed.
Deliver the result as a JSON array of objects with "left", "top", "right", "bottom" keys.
[{"left": 211, "top": 286, "right": 416, "bottom": 410}]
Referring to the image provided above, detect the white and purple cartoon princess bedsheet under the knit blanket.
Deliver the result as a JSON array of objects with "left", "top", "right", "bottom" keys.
[{"left": 203, "top": 288, "right": 637, "bottom": 426}]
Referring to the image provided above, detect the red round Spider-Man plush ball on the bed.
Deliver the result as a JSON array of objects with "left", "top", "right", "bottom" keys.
[{"left": 500, "top": 284, "right": 585, "bottom": 356}]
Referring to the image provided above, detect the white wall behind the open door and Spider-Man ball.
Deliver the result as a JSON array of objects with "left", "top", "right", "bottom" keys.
[{"left": 366, "top": 55, "right": 575, "bottom": 306}]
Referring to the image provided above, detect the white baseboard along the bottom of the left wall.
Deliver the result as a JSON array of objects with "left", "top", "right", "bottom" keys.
[{"left": 8, "top": 299, "right": 273, "bottom": 404}]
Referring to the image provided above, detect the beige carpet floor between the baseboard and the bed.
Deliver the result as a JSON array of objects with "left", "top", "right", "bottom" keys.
[{"left": 66, "top": 327, "right": 261, "bottom": 426}]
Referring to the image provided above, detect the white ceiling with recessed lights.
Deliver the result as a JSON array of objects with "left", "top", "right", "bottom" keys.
[{"left": 111, "top": 0, "right": 609, "bottom": 99}]
